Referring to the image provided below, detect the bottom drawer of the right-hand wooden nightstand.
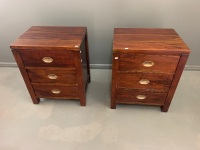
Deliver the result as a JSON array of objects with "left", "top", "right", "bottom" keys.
[{"left": 116, "top": 89, "right": 167, "bottom": 106}]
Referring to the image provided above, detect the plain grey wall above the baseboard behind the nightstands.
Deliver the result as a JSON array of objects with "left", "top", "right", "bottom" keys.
[{"left": 0, "top": 0, "right": 200, "bottom": 66}]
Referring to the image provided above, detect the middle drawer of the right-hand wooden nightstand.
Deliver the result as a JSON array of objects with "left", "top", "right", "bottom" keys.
[{"left": 117, "top": 72, "right": 173, "bottom": 92}]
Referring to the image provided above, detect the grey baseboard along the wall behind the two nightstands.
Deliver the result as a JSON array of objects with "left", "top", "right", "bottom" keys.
[{"left": 0, "top": 62, "right": 200, "bottom": 71}]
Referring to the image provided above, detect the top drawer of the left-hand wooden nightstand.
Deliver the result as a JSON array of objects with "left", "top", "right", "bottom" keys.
[{"left": 20, "top": 50, "right": 75, "bottom": 68}]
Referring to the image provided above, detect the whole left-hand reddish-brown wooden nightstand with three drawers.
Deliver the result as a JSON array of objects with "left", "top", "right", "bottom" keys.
[{"left": 10, "top": 26, "right": 90, "bottom": 106}]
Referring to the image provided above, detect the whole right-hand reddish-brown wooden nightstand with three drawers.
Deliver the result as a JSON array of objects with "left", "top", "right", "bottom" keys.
[{"left": 111, "top": 28, "right": 190, "bottom": 112}]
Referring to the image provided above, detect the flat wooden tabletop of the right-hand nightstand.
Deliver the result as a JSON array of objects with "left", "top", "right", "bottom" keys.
[{"left": 113, "top": 28, "right": 190, "bottom": 54}]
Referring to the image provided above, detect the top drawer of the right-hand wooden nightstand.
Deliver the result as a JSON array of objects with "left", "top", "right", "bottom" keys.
[{"left": 119, "top": 53, "right": 180, "bottom": 73}]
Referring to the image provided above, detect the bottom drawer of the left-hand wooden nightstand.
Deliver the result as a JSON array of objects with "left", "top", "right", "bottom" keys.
[{"left": 33, "top": 84, "right": 79, "bottom": 99}]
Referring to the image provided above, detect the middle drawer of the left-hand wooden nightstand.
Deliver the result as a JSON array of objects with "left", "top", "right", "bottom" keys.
[{"left": 27, "top": 68, "right": 77, "bottom": 84}]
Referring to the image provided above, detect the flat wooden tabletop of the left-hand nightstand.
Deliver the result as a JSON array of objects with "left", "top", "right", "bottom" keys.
[{"left": 10, "top": 26, "right": 87, "bottom": 50}]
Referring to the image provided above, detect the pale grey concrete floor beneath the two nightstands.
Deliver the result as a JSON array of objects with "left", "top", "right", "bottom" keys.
[{"left": 0, "top": 67, "right": 200, "bottom": 150}]
